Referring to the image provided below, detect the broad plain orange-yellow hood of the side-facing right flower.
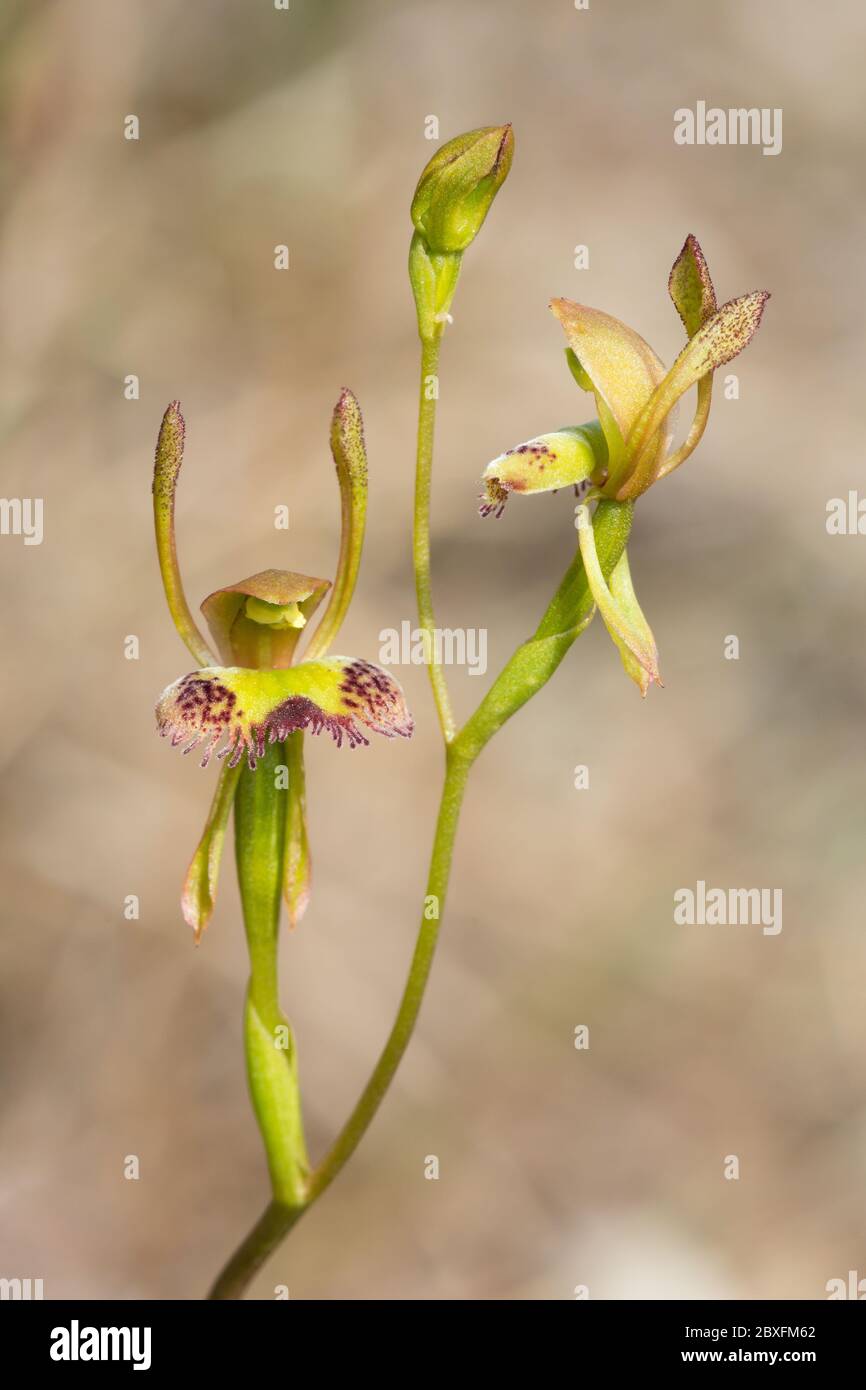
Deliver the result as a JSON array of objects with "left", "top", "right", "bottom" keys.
[{"left": 550, "top": 299, "right": 664, "bottom": 475}]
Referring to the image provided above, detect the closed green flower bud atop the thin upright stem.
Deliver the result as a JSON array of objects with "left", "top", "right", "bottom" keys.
[{"left": 411, "top": 125, "right": 514, "bottom": 256}]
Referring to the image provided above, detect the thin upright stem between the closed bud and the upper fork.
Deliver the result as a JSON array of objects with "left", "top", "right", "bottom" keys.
[{"left": 413, "top": 336, "right": 455, "bottom": 744}]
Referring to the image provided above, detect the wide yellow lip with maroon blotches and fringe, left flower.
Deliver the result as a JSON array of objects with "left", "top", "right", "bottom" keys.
[{"left": 156, "top": 656, "right": 413, "bottom": 767}]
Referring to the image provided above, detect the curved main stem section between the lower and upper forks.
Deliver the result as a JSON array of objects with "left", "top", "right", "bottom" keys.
[{"left": 309, "top": 751, "right": 471, "bottom": 1202}]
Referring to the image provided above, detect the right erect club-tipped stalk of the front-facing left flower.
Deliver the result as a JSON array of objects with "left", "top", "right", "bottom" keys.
[{"left": 307, "top": 388, "right": 367, "bottom": 657}]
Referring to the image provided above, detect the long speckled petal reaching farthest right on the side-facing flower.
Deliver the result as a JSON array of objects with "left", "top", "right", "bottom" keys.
[{"left": 617, "top": 289, "right": 770, "bottom": 500}]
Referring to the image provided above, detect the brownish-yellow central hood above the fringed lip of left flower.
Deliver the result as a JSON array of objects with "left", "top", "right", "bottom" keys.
[{"left": 202, "top": 570, "right": 331, "bottom": 666}]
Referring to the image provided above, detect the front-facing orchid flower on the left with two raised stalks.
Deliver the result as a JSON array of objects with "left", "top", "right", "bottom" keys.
[{"left": 153, "top": 391, "right": 413, "bottom": 941}]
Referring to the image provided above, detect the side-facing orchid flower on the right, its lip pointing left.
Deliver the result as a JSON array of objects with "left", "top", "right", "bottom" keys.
[{"left": 480, "top": 236, "right": 769, "bottom": 695}]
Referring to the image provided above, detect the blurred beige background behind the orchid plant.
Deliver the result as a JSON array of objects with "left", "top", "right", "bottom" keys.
[{"left": 0, "top": 0, "right": 866, "bottom": 1300}]
